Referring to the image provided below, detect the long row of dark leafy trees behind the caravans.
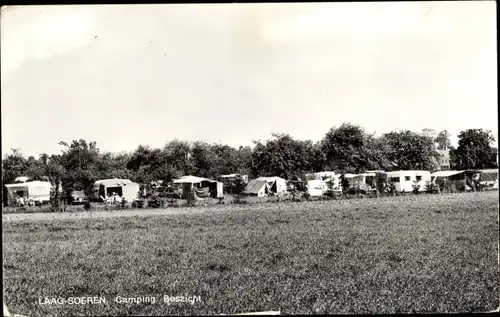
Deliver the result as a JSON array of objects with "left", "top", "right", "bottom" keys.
[{"left": 2, "top": 123, "right": 497, "bottom": 199}]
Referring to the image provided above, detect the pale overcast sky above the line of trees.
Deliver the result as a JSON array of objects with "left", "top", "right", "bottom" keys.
[{"left": 1, "top": 1, "right": 498, "bottom": 156}]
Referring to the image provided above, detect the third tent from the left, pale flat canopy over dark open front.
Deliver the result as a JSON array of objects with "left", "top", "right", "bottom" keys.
[{"left": 173, "top": 175, "right": 224, "bottom": 199}]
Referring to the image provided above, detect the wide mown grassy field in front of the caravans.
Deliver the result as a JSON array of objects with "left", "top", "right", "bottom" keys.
[{"left": 3, "top": 192, "right": 500, "bottom": 316}]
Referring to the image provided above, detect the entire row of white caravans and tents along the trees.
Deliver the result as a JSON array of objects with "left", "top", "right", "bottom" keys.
[{"left": 4, "top": 169, "right": 498, "bottom": 205}]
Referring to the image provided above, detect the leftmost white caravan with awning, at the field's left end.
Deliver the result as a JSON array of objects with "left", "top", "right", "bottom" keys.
[{"left": 4, "top": 181, "right": 52, "bottom": 206}]
